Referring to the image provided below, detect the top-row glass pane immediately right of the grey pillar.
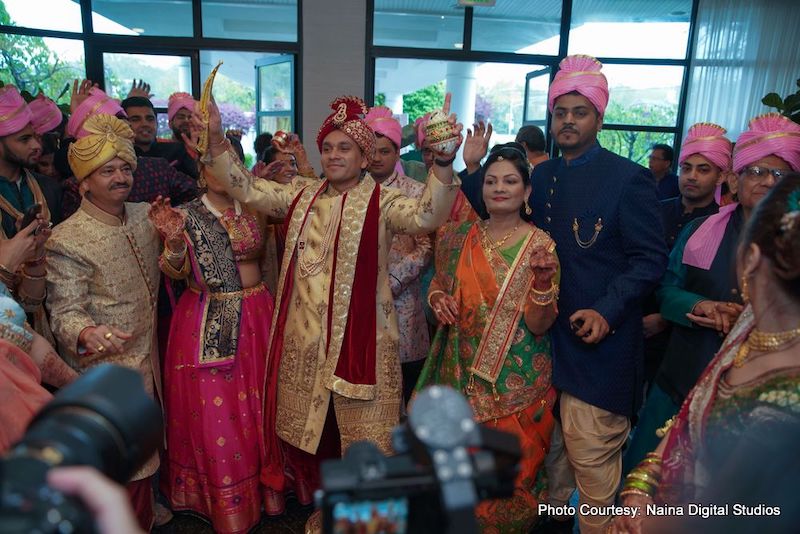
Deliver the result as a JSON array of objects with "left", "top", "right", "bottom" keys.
[{"left": 373, "top": 0, "right": 464, "bottom": 50}]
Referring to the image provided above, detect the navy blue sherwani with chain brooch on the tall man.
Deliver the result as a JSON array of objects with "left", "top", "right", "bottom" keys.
[{"left": 463, "top": 144, "right": 667, "bottom": 417}]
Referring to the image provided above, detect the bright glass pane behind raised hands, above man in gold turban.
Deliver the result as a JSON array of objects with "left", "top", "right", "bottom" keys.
[{"left": 103, "top": 52, "right": 192, "bottom": 101}]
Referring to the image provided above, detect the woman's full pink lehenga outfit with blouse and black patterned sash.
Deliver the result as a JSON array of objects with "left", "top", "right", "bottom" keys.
[{"left": 161, "top": 200, "right": 273, "bottom": 532}]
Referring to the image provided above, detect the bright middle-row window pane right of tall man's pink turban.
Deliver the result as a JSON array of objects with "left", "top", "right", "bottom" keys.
[{"left": 603, "top": 64, "right": 683, "bottom": 126}]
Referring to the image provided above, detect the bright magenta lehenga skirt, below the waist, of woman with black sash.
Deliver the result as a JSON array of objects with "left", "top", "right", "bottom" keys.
[{"left": 161, "top": 284, "right": 273, "bottom": 532}]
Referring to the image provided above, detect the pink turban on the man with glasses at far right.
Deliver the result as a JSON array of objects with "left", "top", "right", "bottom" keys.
[{"left": 733, "top": 113, "right": 800, "bottom": 173}]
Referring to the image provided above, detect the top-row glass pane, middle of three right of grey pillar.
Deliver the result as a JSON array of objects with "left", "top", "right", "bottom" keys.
[{"left": 472, "top": 0, "right": 561, "bottom": 56}]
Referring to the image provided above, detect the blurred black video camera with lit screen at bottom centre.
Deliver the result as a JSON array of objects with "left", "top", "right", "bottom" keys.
[{"left": 316, "top": 386, "right": 522, "bottom": 534}]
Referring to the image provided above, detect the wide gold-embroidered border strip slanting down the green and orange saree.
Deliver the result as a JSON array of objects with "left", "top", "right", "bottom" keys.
[{"left": 469, "top": 228, "right": 550, "bottom": 384}]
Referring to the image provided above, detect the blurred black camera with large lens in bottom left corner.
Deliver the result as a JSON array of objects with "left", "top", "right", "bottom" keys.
[{"left": 0, "top": 365, "right": 163, "bottom": 534}]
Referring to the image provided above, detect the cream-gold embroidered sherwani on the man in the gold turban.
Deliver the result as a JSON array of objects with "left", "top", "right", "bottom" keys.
[{"left": 46, "top": 198, "right": 161, "bottom": 480}]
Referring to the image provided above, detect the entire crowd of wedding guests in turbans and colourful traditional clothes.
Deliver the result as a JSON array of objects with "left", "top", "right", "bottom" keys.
[{"left": 0, "top": 50, "right": 800, "bottom": 533}]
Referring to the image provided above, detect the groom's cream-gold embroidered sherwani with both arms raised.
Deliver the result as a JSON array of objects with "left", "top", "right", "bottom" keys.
[{"left": 206, "top": 153, "right": 460, "bottom": 454}]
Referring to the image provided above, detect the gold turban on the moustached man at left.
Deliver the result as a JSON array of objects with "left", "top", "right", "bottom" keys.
[{"left": 68, "top": 114, "right": 136, "bottom": 182}]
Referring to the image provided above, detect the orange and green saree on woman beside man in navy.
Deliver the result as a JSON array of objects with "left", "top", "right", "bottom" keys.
[{"left": 412, "top": 222, "right": 556, "bottom": 532}]
